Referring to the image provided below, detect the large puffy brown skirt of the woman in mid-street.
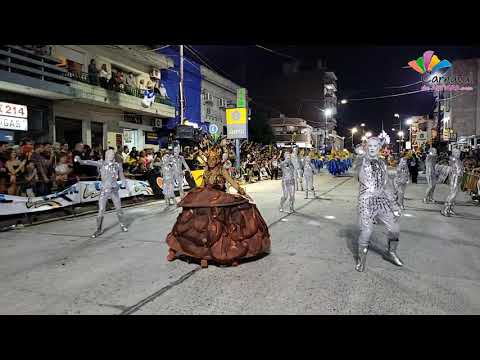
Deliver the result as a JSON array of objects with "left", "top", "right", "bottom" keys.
[{"left": 167, "top": 187, "right": 270, "bottom": 264}]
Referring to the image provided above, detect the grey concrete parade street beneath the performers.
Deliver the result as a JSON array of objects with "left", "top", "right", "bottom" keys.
[{"left": 0, "top": 170, "right": 480, "bottom": 315}]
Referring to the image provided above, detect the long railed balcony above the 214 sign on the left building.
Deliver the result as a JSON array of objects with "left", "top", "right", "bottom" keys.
[{"left": 0, "top": 45, "right": 175, "bottom": 118}]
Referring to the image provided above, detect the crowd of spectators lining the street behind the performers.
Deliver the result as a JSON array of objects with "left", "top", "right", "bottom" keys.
[{"left": 0, "top": 135, "right": 480, "bottom": 200}]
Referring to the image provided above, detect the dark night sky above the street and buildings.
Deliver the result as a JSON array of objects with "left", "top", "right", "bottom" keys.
[{"left": 192, "top": 44, "right": 480, "bottom": 136}]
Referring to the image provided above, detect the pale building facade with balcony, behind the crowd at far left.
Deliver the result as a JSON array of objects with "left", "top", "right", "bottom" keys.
[{"left": 0, "top": 45, "right": 175, "bottom": 149}]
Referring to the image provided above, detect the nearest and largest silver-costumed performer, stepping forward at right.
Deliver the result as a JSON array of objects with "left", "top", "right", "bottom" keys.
[{"left": 354, "top": 137, "right": 403, "bottom": 272}]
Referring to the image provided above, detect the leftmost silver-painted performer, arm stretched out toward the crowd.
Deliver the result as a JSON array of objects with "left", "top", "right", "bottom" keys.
[{"left": 75, "top": 150, "right": 128, "bottom": 238}]
